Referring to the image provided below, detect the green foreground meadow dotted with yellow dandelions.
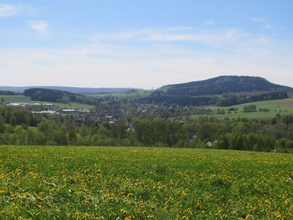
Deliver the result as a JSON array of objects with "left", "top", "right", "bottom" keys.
[{"left": 0, "top": 146, "right": 293, "bottom": 219}]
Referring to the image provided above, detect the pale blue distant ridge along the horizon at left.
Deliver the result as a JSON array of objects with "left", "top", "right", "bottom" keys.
[{"left": 0, "top": 86, "right": 133, "bottom": 94}]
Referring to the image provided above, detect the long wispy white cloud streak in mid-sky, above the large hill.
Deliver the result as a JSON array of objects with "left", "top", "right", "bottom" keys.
[{"left": 94, "top": 27, "right": 251, "bottom": 51}]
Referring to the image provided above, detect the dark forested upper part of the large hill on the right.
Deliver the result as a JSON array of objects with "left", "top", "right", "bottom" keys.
[{"left": 161, "top": 76, "right": 293, "bottom": 96}]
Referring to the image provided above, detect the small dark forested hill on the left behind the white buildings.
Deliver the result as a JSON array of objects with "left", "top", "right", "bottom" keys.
[{"left": 23, "top": 88, "right": 98, "bottom": 105}]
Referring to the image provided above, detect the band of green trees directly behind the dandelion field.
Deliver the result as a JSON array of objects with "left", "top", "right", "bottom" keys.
[{"left": 0, "top": 107, "right": 293, "bottom": 151}]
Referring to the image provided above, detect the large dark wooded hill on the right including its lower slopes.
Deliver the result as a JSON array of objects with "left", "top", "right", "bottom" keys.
[{"left": 141, "top": 76, "right": 293, "bottom": 106}]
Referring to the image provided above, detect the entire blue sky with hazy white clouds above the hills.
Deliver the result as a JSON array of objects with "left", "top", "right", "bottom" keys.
[{"left": 0, "top": 0, "right": 293, "bottom": 89}]
